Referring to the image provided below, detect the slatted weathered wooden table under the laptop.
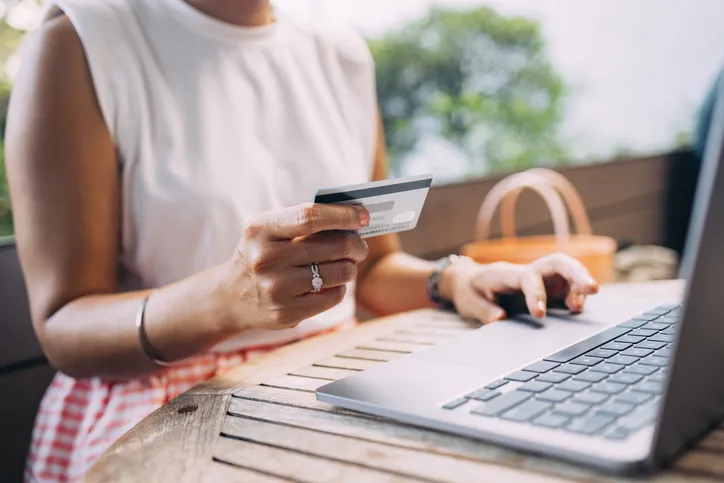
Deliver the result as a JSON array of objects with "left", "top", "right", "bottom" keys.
[{"left": 86, "top": 282, "right": 724, "bottom": 483}]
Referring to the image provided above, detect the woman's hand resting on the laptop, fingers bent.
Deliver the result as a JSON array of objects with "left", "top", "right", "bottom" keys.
[{"left": 441, "top": 254, "right": 598, "bottom": 323}]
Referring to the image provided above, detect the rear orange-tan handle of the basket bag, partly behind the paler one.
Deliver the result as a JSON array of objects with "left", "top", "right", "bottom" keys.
[{"left": 500, "top": 168, "right": 593, "bottom": 237}]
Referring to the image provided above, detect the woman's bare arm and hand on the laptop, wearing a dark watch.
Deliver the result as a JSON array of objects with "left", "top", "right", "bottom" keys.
[{"left": 357, "top": 118, "right": 598, "bottom": 322}]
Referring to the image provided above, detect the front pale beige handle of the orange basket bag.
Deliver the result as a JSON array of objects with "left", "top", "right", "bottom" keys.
[{"left": 475, "top": 171, "right": 570, "bottom": 243}]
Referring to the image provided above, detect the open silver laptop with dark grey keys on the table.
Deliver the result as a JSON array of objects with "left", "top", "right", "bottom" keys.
[{"left": 317, "top": 75, "right": 724, "bottom": 473}]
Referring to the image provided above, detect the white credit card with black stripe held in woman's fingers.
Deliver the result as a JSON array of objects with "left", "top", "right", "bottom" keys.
[{"left": 314, "top": 175, "right": 432, "bottom": 238}]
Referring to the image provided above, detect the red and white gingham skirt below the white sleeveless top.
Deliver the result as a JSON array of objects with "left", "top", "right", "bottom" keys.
[{"left": 25, "top": 321, "right": 354, "bottom": 482}]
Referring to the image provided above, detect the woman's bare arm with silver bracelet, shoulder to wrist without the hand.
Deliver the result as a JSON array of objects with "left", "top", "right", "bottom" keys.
[{"left": 6, "top": 16, "right": 240, "bottom": 377}]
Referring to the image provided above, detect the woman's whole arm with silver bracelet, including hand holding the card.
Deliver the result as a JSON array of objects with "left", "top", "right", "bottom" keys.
[{"left": 6, "top": 16, "right": 369, "bottom": 378}]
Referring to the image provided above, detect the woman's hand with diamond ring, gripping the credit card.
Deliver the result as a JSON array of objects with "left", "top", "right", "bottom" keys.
[{"left": 220, "top": 204, "right": 369, "bottom": 331}]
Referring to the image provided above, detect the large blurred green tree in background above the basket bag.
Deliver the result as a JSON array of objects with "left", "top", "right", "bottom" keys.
[{"left": 369, "top": 7, "right": 567, "bottom": 175}]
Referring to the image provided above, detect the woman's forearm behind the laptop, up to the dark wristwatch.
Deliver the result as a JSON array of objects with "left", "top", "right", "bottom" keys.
[{"left": 357, "top": 251, "right": 451, "bottom": 315}]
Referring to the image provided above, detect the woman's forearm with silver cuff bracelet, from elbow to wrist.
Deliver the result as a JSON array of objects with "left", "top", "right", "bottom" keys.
[{"left": 39, "top": 266, "right": 233, "bottom": 379}]
